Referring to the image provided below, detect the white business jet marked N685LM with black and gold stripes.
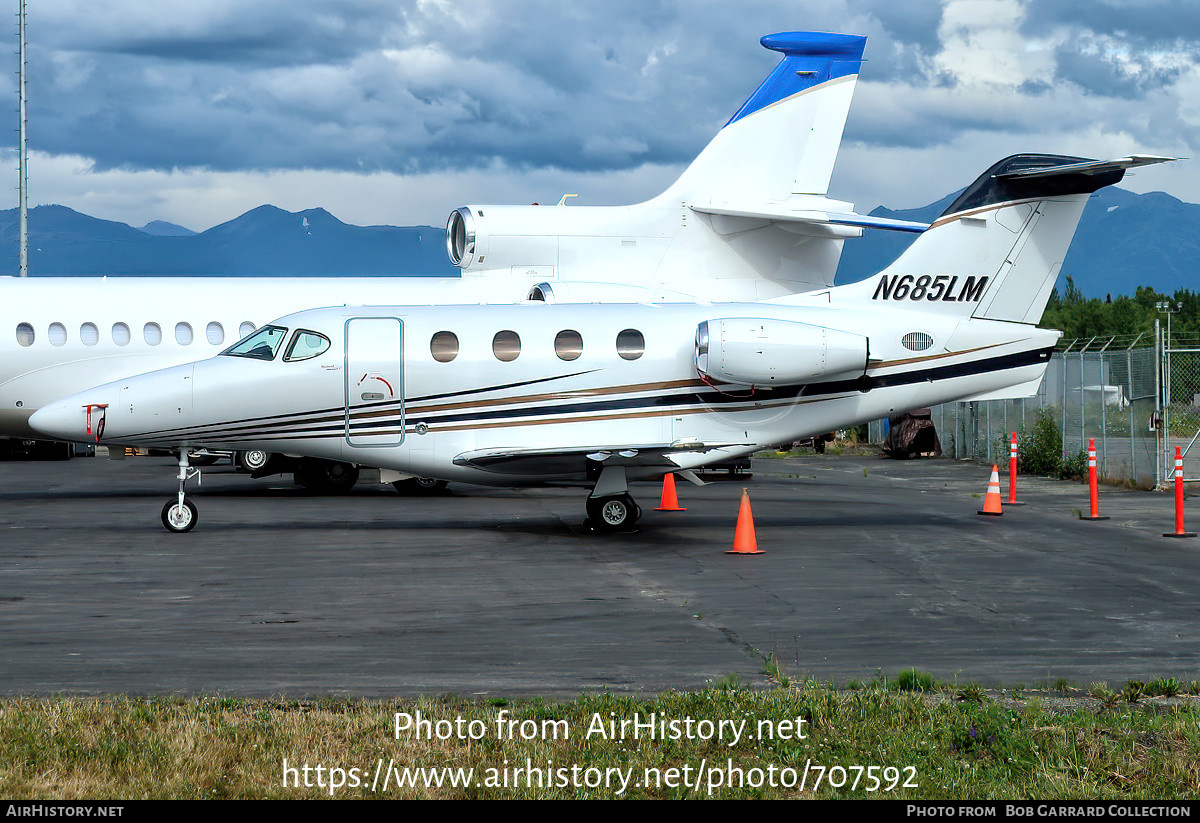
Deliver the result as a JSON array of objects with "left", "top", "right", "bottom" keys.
[{"left": 31, "top": 155, "right": 1166, "bottom": 531}]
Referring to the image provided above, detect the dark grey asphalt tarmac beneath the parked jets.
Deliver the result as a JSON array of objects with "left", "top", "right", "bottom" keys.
[{"left": 0, "top": 455, "right": 1200, "bottom": 697}]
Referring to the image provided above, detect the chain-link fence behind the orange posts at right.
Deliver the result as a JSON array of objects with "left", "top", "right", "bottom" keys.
[{"left": 870, "top": 332, "right": 1200, "bottom": 486}]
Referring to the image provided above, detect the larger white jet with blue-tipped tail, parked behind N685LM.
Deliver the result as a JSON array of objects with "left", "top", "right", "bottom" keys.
[{"left": 0, "top": 32, "right": 897, "bottom": 487}]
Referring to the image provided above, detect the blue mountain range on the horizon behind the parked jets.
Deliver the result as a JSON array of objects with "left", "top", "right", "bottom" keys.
[{"left": 0, "top": 187, "right": 1200, "bottom": 298}]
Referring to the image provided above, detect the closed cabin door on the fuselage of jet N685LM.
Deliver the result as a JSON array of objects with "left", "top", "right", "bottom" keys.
[{"left": 346, "top": 317, "right": 404, "bottom": 447}]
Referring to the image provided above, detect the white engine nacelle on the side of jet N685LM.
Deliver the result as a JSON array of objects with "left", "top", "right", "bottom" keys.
[{"left": 695, "top": 318, "right": 869, "bottom": 386}]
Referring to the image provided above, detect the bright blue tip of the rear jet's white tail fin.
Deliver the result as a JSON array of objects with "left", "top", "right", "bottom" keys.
[{"left": 725, "top": 31, "right": 866, "bottom": 126}]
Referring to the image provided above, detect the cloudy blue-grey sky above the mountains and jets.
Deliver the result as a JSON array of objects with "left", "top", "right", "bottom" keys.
[{"left": 9, "top": 0, "right": 1200, "bottom": 228}]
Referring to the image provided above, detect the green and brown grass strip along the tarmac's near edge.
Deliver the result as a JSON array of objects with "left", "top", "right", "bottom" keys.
[{"left": 0, "top": 678, "right": 1200, "bottom": 799}]
